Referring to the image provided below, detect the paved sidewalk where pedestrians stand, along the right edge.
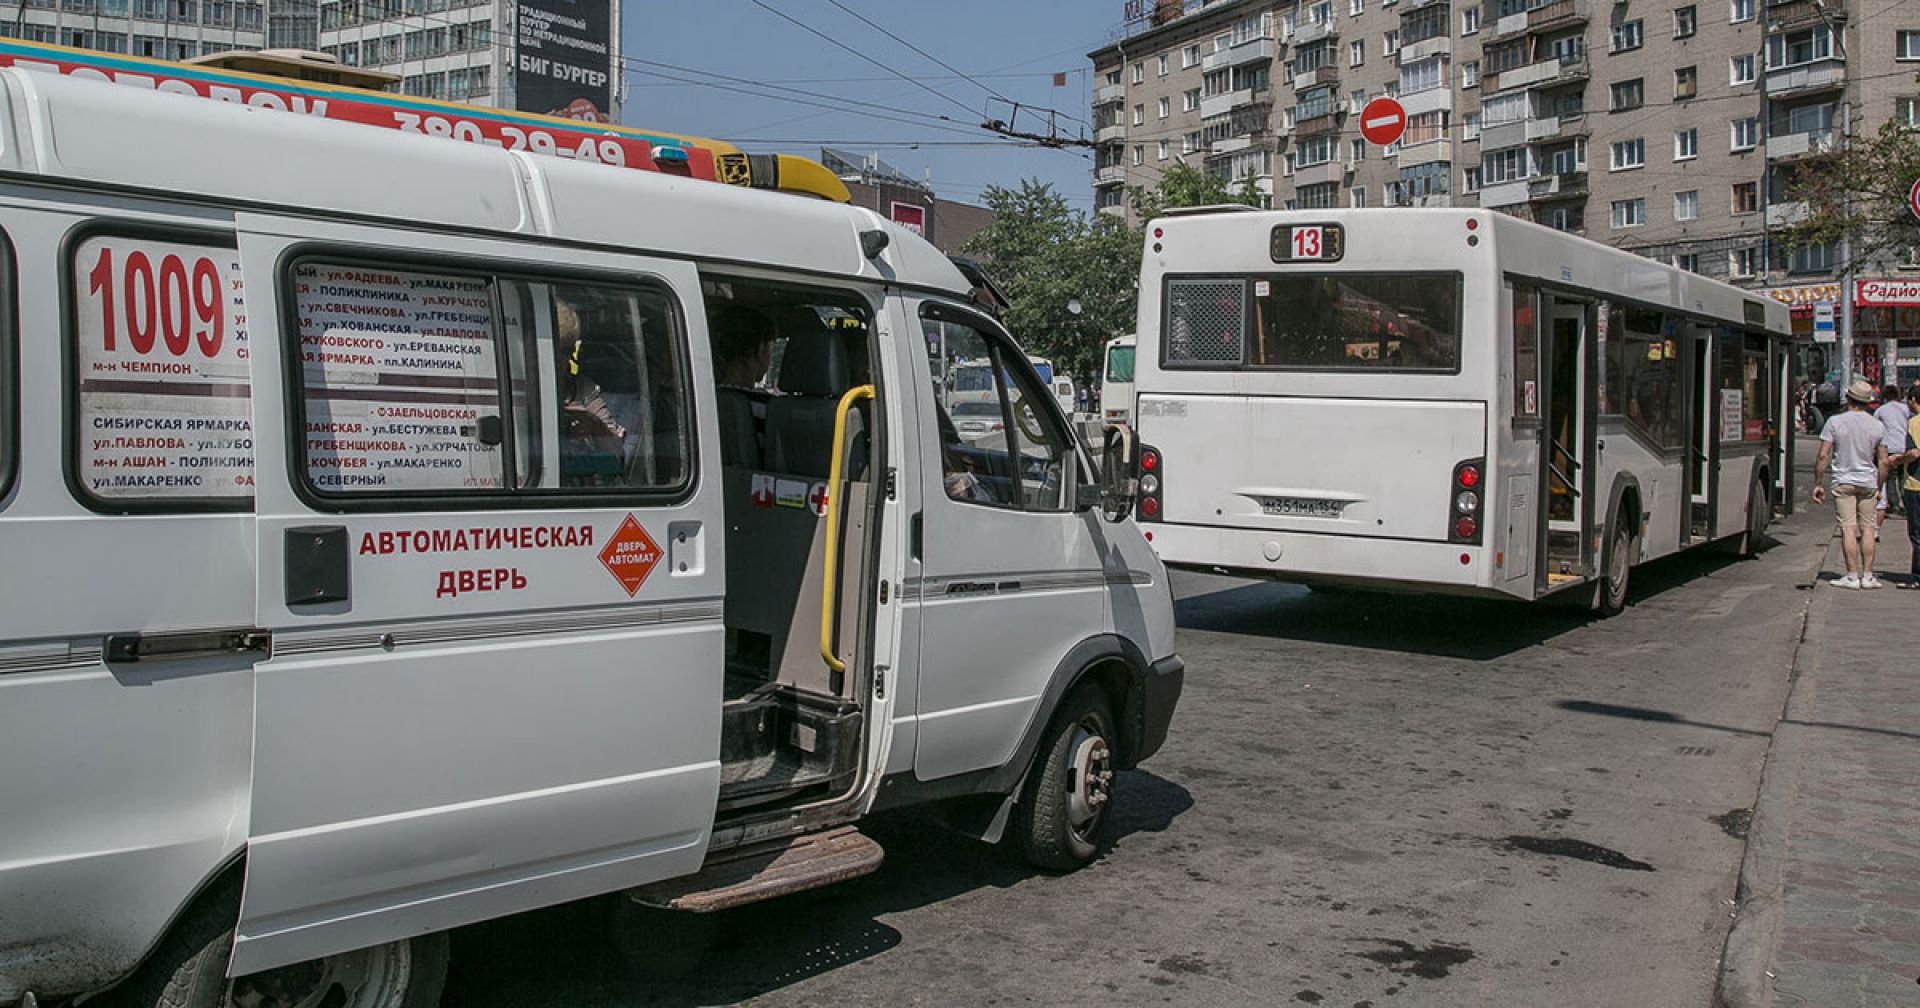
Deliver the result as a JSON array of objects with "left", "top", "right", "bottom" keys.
[{"left": 1718, "top": 516, "right": 1920, "bottom": 1008}]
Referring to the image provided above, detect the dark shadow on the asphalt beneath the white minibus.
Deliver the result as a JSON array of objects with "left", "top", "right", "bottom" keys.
[{"left": 444, "top": 770, "right": 1194, "bottom": 1008}]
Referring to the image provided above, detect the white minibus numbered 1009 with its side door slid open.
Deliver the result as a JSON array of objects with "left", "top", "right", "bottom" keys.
[{"left": 0, "top": 67, "right": 1183, "bottom": 1008}]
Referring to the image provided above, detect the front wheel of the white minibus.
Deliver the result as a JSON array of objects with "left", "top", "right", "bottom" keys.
[{"left": 1014, "top": 685, "right": 1117, "bottom": 872}]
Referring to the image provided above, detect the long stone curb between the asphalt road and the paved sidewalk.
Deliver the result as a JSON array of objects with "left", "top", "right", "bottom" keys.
[{"left": 1713, "top": 534, "right": 1834, "bottom": 1008}]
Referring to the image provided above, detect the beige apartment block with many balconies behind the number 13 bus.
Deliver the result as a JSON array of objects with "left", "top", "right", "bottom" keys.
[{"left": 1089, "top": 0, "right": 1920, "bottom": 382}]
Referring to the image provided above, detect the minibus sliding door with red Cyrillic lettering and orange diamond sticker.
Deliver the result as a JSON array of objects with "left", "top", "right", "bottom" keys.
[{"left": 232, "top": 215, "right": 724, "bottom": 973}]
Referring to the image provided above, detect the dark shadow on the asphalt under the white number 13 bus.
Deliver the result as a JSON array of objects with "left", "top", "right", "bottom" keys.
[{"left": 1175, "top": 540, "right": 1780, "bottom": 660}]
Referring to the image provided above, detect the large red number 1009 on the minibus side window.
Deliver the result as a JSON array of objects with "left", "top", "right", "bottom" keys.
[{"left": 86, "top": 248, "right": 227, "bottom": 357}]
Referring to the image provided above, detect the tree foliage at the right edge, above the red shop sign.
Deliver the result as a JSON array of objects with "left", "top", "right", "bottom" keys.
[{"left": 1780, "top": 121, "right": 1920, "bottom": 263}]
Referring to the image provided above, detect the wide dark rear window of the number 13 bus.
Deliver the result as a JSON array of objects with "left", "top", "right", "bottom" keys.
[{"left": 1167, "top": 273, "right": 1461, "bottom": 371}]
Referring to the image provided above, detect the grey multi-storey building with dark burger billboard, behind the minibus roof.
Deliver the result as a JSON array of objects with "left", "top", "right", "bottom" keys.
[{"left": 0, "top": 0, "right": 620, "bottom": 121}]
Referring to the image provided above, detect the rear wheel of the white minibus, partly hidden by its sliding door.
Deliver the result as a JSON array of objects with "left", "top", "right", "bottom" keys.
[{"left": 109, "top": 872, "right": 447, "bottom": 1008}]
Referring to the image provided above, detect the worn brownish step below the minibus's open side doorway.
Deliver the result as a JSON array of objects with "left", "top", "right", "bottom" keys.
[{"left": 628, "top": 826, "right": 885, "bottom": 914}]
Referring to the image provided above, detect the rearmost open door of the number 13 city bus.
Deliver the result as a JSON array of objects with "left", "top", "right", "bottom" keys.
[{"left": 1540, "top": 298, "right": 1594, "bottom": 576}]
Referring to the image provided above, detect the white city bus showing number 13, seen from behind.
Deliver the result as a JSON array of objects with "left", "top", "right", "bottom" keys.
[{"left": 1135, "top": 209, "right": 1791, "bottom": 612}]
